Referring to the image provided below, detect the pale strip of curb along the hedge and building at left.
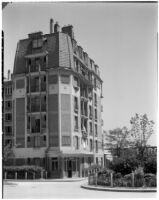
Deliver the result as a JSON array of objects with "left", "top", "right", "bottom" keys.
[{"left": 3, "top": 178, "right": 87, "bottom": 183}]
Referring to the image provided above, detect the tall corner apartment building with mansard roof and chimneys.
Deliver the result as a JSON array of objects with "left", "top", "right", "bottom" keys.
[{"left": 4, "top": 19, "right": 104, "bottom": 178}]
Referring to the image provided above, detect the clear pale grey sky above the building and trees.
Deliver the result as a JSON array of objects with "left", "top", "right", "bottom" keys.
[{"left": 2, "top": 2, "right": 158, "bottom": 145}]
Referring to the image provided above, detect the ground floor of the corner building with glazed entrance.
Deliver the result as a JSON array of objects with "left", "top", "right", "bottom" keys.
[{"left": 4, "top": 154, "right": 103, "bottom": 178}]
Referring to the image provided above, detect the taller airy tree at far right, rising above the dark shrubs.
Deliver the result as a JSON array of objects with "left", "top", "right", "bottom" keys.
[{"left": 130, "top": 114, "right": 154, "bottom": 165}]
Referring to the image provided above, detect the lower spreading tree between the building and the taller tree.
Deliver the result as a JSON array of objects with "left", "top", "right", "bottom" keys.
[{"left": 105, "top": 127, "right": 129, "bottom": 157}]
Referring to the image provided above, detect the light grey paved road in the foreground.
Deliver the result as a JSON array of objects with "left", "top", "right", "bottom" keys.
[{"left": 3, "top": 181, "right": 156, "bottom": 199}]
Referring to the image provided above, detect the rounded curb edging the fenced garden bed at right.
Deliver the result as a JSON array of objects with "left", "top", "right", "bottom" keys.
[{"left": 81, "top": 185, "right": 157, "bottom": 192}]
